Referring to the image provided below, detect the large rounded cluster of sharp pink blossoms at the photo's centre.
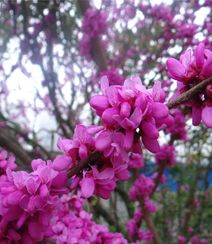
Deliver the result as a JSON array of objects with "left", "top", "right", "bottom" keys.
[{"left": 90, "top": 76, "right": 173, "bottom": 155}]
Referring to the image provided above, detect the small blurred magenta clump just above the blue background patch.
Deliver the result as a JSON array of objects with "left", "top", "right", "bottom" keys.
[{"left": 155, "top": 144, "right": 176, "bottom": 167}]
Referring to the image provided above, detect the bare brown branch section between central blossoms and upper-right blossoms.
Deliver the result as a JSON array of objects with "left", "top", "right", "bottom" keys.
[{"left": 166, "top": 77, "right": 212, "bottom": 109}]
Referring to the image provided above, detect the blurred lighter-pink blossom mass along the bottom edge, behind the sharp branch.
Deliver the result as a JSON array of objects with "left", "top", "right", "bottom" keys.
[{"left": 48, "top": 194, "right": 140, "bottom": 244}]
